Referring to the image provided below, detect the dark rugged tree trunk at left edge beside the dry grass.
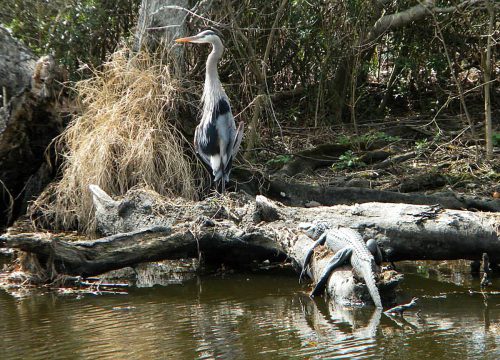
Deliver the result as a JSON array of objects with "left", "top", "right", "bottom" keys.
[{"left": 0, "top": 27, "right": 66, "bottom": 228}]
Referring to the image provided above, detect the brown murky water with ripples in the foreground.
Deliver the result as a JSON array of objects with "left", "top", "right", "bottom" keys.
[{"left": 0, "top": 263, "right": 500, "bottom": 359}]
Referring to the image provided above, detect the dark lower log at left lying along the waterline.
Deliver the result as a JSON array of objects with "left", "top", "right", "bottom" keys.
[{"left": 0, "top": 225, "right": 286, "bottom": 279}]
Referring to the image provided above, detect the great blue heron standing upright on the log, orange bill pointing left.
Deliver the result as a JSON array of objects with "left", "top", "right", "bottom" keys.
[{"left": 175, "top": 30, "right": 243, "bottom": 193}]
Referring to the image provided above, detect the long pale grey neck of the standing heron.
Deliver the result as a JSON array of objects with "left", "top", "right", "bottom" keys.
[{"left": 202, "top": 40, "right": 225, "bottom": 109}]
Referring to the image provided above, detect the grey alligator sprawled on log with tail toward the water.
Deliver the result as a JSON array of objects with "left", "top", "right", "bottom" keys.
[{"left": 299, "top": 222, "right": 382, "bottom": 308}]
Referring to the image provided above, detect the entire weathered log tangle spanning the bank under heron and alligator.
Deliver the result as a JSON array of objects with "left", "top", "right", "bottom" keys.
[{"left": 0, "top": 186, "right": 500, "bottom": 303}]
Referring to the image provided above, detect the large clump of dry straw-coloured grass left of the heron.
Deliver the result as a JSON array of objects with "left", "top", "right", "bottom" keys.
[{"left": 31, "top": 50, "right": 197, "bottom": 233}]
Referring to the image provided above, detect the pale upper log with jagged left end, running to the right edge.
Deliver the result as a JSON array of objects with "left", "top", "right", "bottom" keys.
[{"left": 69, "top": 186, "right": 500, "bottom": 262}]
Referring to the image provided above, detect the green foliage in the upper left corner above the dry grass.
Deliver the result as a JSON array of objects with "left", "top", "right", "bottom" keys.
[{"left": 0, "top": 0, "right": 140, "bottom": 76}]
